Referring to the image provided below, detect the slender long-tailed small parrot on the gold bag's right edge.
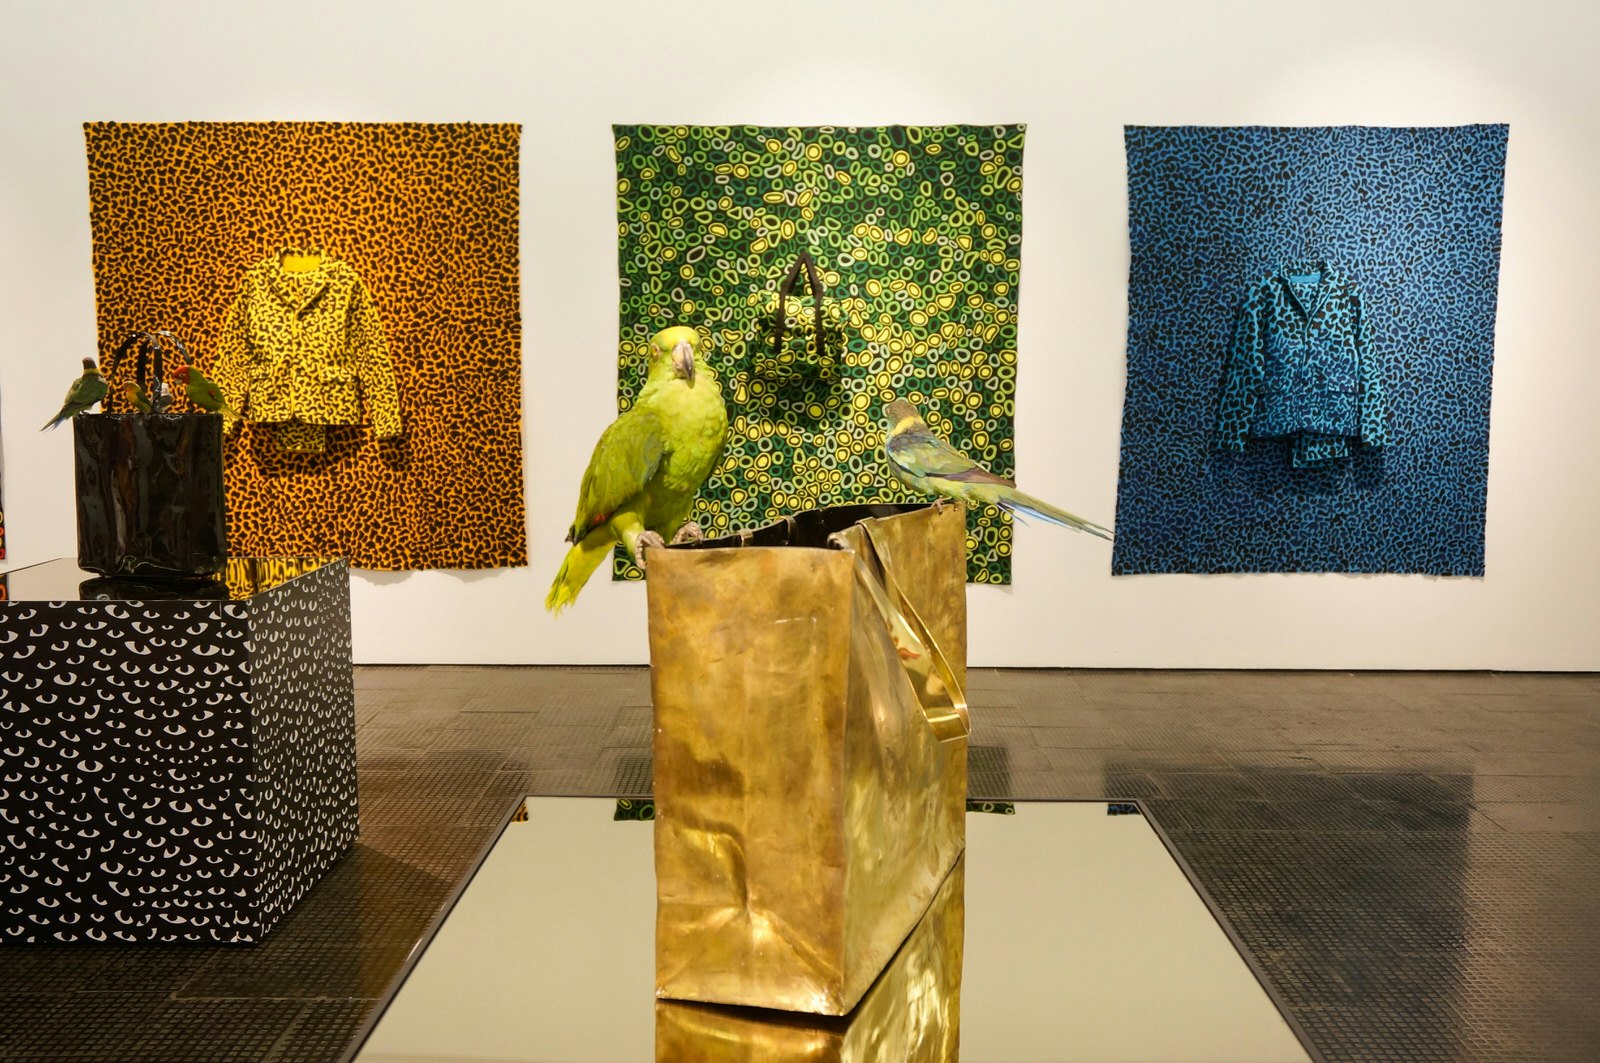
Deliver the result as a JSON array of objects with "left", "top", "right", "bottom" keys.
[{"left": 883, "top": 399, "right": 1110, "bottom": 540}]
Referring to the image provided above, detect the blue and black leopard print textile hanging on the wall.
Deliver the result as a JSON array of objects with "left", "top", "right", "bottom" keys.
[{"left": 1112, "top": 125, "right": 1507, "bottom": 576}]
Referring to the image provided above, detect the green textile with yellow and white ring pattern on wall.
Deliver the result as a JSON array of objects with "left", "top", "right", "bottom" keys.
[{"left": 613, "top": 125, "right": 1024, "bottom": 583}]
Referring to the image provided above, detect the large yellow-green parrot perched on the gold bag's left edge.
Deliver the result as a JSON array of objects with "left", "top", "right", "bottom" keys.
[{"left": 544, "top": 325, "right": 728, "bottom": 613}]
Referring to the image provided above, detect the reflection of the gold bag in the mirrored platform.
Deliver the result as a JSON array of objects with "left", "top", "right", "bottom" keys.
[{"left": 656, "top": 860, "right": 966, "bottom": 1063}]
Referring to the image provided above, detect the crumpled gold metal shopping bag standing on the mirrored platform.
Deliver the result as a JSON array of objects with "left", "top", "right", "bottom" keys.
[{"left": 650, "top": 503, "right": 966, "bottom": 1015}]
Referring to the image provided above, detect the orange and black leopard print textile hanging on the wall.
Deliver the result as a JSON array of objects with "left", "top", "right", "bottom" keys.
[{"left": 85, "top": 122, "right": 528, "bottom": 568}]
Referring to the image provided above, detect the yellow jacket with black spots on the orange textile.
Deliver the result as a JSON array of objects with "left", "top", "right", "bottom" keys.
[{"left": 213, "top": 251, "right": 400, "bottom": 439}]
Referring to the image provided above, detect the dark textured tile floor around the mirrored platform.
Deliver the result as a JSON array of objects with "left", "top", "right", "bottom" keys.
[{"left": 0, "top": 668, "right": 1600, "bottom": 1063}]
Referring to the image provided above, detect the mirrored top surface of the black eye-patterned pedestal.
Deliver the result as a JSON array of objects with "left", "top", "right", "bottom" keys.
[{"left": 0, "top": 557, "right": 338, "bottom": 602}]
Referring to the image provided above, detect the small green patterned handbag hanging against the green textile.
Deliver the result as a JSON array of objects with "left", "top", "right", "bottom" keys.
[{"left": 750, "top": 251, "right": 845, "bottom": 387}]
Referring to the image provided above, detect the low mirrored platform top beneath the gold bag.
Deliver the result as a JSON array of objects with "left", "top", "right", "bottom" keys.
[{"left": 354, "top": 797, "right": 1310, "bottom": 1063}]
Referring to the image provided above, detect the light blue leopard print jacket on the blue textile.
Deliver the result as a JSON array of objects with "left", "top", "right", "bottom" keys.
[{"left": 1218, "top": 259, "right": 1387, "bottom": 466}]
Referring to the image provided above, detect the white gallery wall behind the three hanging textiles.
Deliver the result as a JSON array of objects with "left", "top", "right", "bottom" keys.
[{"left": 0, "top": 0, "right": 1600, "bottom": 669}]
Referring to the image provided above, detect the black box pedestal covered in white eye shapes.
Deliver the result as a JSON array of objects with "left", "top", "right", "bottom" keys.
[{"left": 0, "top": 559, "right": 357, "bottom": 945}]
